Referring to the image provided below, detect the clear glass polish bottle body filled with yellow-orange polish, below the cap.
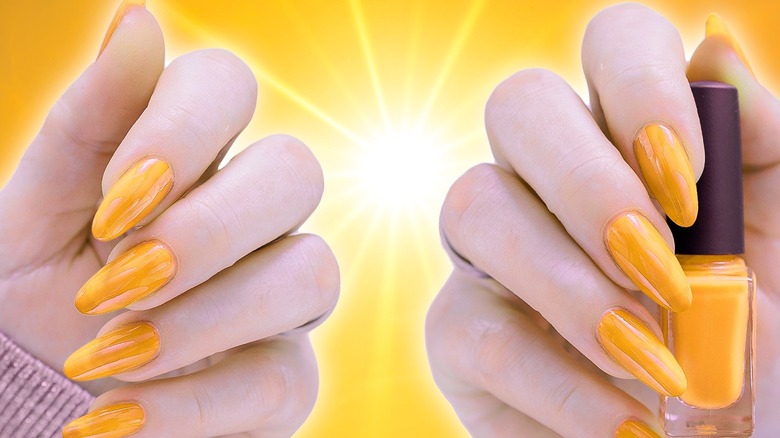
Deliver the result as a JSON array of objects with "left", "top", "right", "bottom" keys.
[{"left": 661, "top": 255, "right": 756, "bottom": 436}]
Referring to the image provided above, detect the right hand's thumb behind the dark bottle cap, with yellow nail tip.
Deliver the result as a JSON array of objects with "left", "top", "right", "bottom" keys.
[{"left": 688, "top": 15, "right": 780, "bottom": 290}]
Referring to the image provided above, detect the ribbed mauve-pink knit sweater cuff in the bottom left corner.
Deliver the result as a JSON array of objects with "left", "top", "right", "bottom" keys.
[{"left": 0, "top": 332, "right": 94, "bottom": 437}]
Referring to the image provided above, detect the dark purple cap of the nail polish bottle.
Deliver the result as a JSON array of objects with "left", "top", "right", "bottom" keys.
[{"left": 667, "top": 82, "right": 745, "bottom": 255}]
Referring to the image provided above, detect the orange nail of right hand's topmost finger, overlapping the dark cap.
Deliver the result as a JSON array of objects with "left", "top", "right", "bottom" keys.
[{"left": 634, "top": 124, "right": 699, "bottom": 227}]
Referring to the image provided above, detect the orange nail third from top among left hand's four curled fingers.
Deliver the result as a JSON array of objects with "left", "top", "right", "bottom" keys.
[{"left": 64, "top": 322, "right": 160, "bottom": 380}]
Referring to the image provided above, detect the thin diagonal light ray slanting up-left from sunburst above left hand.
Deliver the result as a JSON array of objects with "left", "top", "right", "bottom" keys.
[{"left": 155, "top": 2, "right": 366, "bottom": 147}]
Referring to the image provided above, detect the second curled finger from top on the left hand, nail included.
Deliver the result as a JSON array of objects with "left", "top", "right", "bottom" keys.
[{"left": 76, "top": 135, "right": 323, "bottom": 314}]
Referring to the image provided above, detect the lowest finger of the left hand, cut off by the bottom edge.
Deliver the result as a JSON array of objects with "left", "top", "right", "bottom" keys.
[{"left": 63, "top": 335, "right": 318, "bottom": 438}]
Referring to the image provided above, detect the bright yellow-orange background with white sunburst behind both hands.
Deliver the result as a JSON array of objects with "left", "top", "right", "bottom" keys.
[{"left": 0, "top": 0, "right": 780, "bottom": 437}]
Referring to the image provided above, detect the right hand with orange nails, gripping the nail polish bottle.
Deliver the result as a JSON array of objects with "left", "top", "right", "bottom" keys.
[{"left": 427, "top": 5, "right": 780, "bottom": 437}]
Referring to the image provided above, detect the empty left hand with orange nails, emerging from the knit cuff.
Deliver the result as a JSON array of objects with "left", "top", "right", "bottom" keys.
[{"left": 0, "top": 2, "right": 339, "bottom": 437}]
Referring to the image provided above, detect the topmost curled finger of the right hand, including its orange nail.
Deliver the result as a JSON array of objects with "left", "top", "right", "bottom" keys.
[{"left": 582, "top": 4, "right": 704, "bottom": 226}]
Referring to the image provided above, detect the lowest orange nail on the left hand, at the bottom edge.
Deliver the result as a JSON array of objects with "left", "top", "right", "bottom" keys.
[{"left": 62, "top": 403, "right": 146, "bottom": 438}]
